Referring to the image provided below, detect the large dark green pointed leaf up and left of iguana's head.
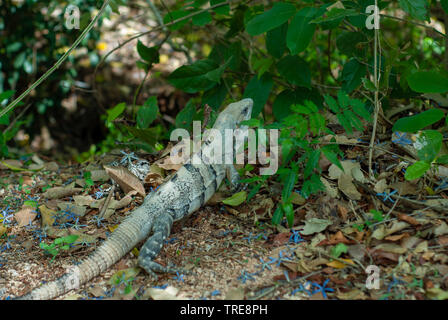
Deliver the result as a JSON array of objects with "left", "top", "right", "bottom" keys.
[{"left": 168, "top": 59, "right": 230, "bottom": 93}]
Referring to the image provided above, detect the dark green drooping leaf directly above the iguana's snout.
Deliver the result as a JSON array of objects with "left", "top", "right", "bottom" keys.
[{"left": 243, "top": 73, "right": 274, "bottom": 118}]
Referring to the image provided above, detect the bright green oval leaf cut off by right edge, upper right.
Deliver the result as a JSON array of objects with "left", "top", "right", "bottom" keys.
[{"left": 407, "top": 70, "right": 448, "bottom": 93}]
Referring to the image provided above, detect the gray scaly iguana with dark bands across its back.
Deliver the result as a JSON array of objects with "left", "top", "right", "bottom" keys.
[{"left": 17, "top": 99, "right": 253, "bottom": 300}]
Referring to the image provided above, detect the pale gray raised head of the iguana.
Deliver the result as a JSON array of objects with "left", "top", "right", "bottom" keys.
[{"left": 214, "top": 98, "right": 254, "bottom": 129}]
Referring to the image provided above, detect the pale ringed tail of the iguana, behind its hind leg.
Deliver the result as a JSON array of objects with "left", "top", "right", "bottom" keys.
[{"left": 15, "top": 208, "right": 146, "bottom": 300}]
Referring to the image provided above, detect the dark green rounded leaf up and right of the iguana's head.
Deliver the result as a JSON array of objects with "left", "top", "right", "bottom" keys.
[{"left": 277, "top": 55, "right": 311, "bottom": 88}]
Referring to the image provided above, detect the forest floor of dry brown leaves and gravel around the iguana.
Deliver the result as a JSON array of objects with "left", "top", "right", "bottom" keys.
[{"left": 0, "top": 142, "right": 448, "bottom": 299}]
